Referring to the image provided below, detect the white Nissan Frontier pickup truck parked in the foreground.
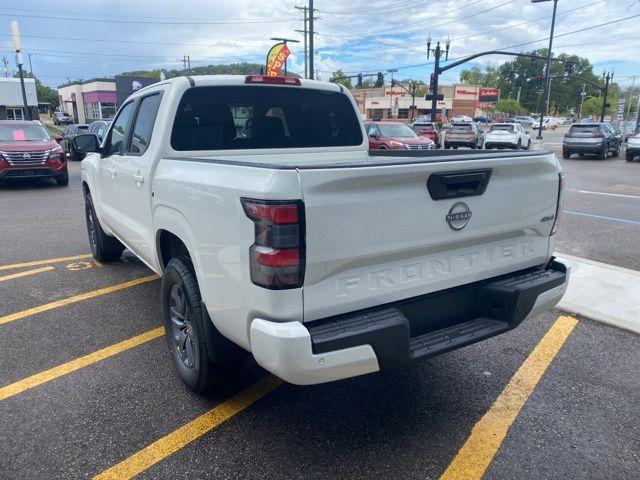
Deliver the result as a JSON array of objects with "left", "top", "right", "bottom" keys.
[{"left": 74, "top": 75, "right": 569, "bottom": 391}]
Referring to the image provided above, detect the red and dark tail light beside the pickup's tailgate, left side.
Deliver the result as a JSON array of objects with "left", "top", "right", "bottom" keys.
[{"left": 242, "top": 198, "right": 305, "bottom": 290}]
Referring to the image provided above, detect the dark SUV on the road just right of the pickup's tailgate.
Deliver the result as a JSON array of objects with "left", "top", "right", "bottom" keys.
[{"left": 562, "top": 122, "right": 623, "bottom": 160}]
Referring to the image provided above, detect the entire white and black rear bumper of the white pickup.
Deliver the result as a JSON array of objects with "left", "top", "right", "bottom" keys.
[{"left": 251, "top": 260, "right": 570, "bottom": 385}]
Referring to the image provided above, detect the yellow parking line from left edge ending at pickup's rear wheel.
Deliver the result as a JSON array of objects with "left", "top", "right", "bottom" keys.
[{"left": 0, "top": 327, "right": 164, "bottom": 400}]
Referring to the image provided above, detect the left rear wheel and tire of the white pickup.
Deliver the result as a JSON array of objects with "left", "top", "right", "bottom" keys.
[{"left": 160, "top": 257, "right": 244, "bottom": 393}]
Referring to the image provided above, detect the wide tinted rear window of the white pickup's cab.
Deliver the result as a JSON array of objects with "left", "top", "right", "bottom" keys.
[{"left": 171, "top": 86, "right": 362, "bottom": 150}]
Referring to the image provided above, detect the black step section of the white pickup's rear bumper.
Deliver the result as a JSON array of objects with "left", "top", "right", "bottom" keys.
[{"left": 305, "top": 260, "right": 568, "bottom": 369}]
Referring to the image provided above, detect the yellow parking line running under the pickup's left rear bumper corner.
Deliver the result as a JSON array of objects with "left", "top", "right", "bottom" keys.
[{"left": 93, "top": 375, "right": 282, "bottom": 480}]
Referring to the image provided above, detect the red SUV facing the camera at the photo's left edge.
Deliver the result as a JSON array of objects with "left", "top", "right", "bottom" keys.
[{"left": 0, "top": 120, "right": 69, "bottom": 185}]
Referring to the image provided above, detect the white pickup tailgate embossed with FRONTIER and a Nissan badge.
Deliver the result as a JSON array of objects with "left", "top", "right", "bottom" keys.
[{"left": 299, "top": 152, "right": 559, "bottom": 322}]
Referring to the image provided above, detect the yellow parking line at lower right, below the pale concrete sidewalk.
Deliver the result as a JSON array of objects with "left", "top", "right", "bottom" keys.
[{"left": 440, "top": 316, "right": 578, "bottom": 480}]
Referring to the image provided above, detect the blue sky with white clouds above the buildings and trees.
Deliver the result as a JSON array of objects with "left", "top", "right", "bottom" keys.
[{"left": 0, "top": 0, "right": 640, "bottom": 87}]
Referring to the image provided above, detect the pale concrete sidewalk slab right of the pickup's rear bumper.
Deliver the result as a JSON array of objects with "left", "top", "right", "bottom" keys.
[{"left": 557, "top": 253, "right": 640, "bottom": 333}]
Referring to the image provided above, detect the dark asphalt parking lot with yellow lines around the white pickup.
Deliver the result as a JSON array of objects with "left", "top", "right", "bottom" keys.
[{"left": 0, "top": 157, "right": 640, "bottom": 479}]
